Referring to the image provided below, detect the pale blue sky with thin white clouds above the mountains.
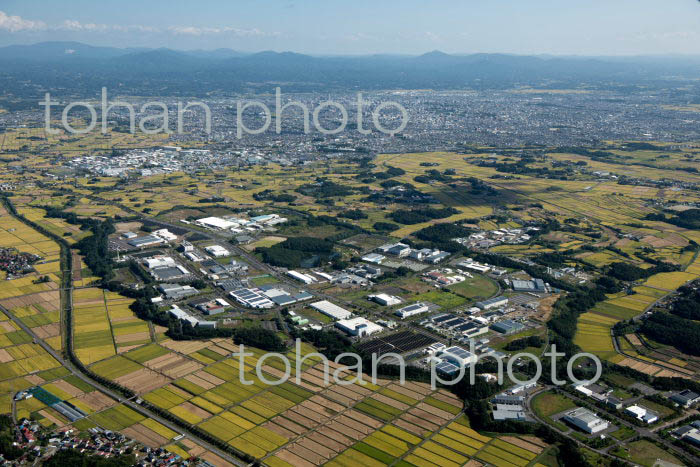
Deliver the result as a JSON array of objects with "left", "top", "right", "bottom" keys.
[{"left": 0, "top": 0, "right": 700, "bottom": 56}]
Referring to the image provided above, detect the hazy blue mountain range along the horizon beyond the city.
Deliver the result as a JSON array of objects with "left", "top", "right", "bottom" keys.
[{"left": 0, "top": 42, "right": 700, "bottom": 94}]
